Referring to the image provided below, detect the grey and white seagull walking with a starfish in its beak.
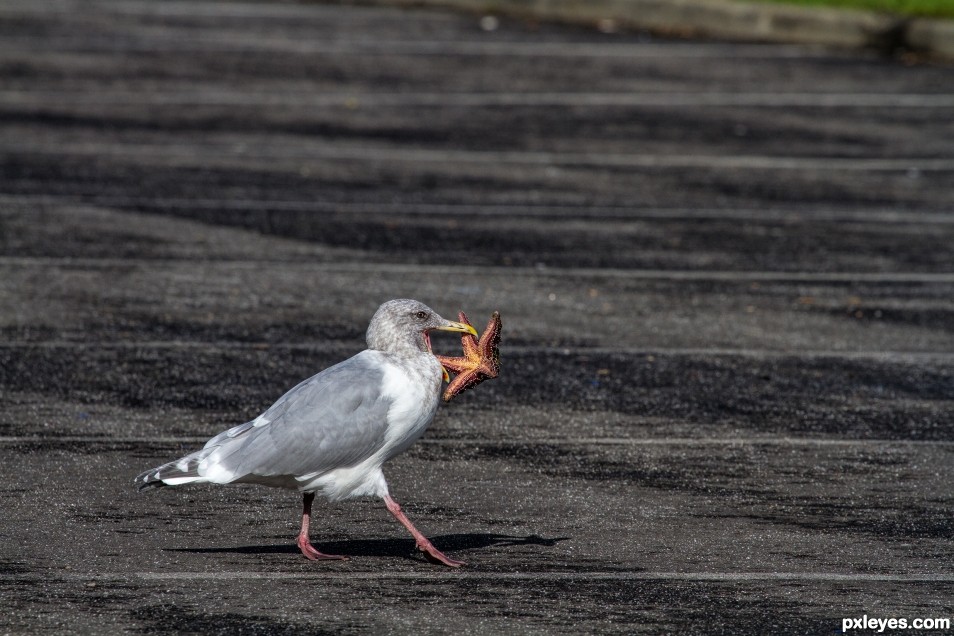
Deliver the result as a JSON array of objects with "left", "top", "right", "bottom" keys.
[{"left": 135, "top": 299, "right": 477, "bottom": 567}]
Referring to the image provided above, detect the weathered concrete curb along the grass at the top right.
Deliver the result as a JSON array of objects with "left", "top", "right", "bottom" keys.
[{"left": 344, "top": 0, "right": 954, "bottom": 59}]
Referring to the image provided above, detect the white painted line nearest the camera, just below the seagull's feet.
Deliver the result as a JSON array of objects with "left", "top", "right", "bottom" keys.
[{"left": 27, "top": 568, "right": 954, "bottom": 583}]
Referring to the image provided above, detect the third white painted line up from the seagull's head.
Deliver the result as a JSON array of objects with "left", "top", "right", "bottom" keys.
[{"left": 9, "top": 136, "right": 954, "bottom": 174}]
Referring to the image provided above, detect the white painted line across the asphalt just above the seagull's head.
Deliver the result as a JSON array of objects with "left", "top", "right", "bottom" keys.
[{"left": 0, "top": 256, "right": 954, "bottom": 285}]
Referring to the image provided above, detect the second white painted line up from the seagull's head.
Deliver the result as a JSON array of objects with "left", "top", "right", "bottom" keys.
[{"left": 7, "top": 192, "right": 954, "bottom": 225}]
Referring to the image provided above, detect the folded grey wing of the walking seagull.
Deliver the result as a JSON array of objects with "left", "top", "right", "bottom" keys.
[{"left": 203, "top": 351, "right": 391, "bottom": 481}]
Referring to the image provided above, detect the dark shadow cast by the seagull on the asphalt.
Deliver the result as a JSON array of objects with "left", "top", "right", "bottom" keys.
[{"left": 164, "top": 533, "right": 570, "bottom": 558}]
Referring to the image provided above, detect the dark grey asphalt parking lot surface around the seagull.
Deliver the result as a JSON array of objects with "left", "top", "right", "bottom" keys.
[{"left": 0, "top": 0, "right": 954, "bottom": 635}]
